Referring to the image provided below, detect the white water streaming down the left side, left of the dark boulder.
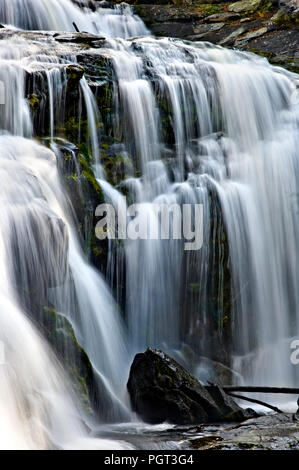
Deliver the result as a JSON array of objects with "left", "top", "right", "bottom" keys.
[{"left": 0, "top": 3, "right": 136, "bottom": 449}]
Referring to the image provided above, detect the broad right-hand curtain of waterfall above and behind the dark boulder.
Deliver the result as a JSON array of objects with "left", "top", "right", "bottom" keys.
[{"left": 98, "top": 38, "right": 299, "bottom": 385}]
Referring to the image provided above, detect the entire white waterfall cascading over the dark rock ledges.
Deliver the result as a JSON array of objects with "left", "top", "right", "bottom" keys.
[{"left": 0, "top": 0, "right": 299, "bottom": 448}]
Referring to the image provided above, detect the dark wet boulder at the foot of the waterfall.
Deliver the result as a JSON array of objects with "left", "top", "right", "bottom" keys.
[{"left": 127, "top": 349, "right": 254, "bottom": 424}]
